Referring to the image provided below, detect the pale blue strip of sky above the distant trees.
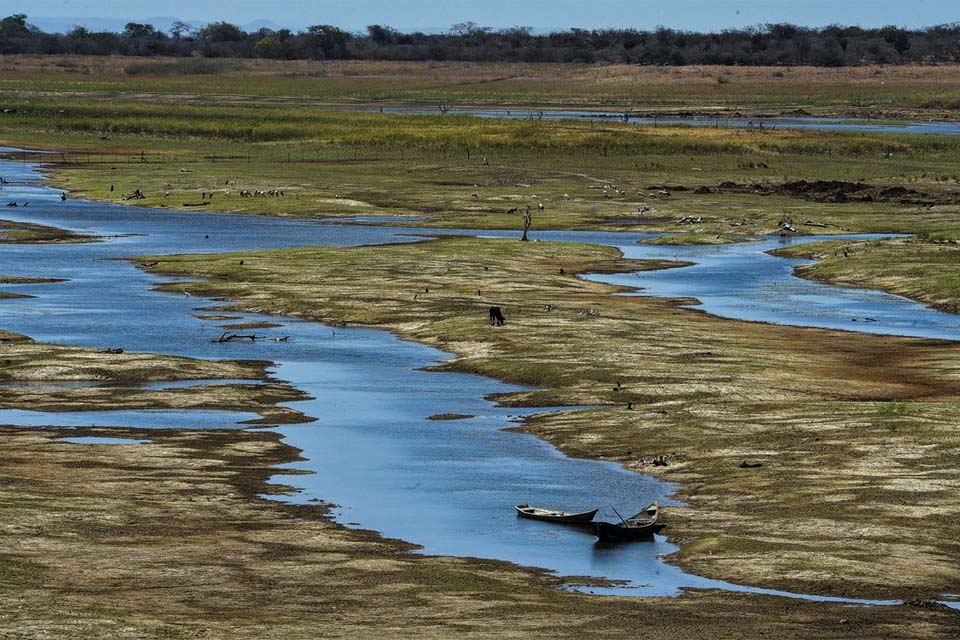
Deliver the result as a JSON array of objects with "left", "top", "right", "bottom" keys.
[{"left": 7, "top": 0, "right": 960, "bottom": 31}]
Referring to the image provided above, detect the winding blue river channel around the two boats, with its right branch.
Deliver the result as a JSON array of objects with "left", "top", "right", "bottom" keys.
[{"left": 0, "top": 154, "right": 960, "bottom": 604}]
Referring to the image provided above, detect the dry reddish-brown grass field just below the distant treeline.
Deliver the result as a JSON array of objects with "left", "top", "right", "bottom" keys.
[{"left": 0, "top": 55, "right": 960, "bottom": 112}]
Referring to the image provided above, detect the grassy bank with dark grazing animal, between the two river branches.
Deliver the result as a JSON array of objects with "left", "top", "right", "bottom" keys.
[{"left": 137, "top": 238, "right": 960, "bottom": 598}]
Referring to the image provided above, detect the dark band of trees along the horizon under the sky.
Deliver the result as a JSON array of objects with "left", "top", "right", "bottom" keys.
[{"left": 0, "top": 14, "right": 960, "bottom": 67}]
